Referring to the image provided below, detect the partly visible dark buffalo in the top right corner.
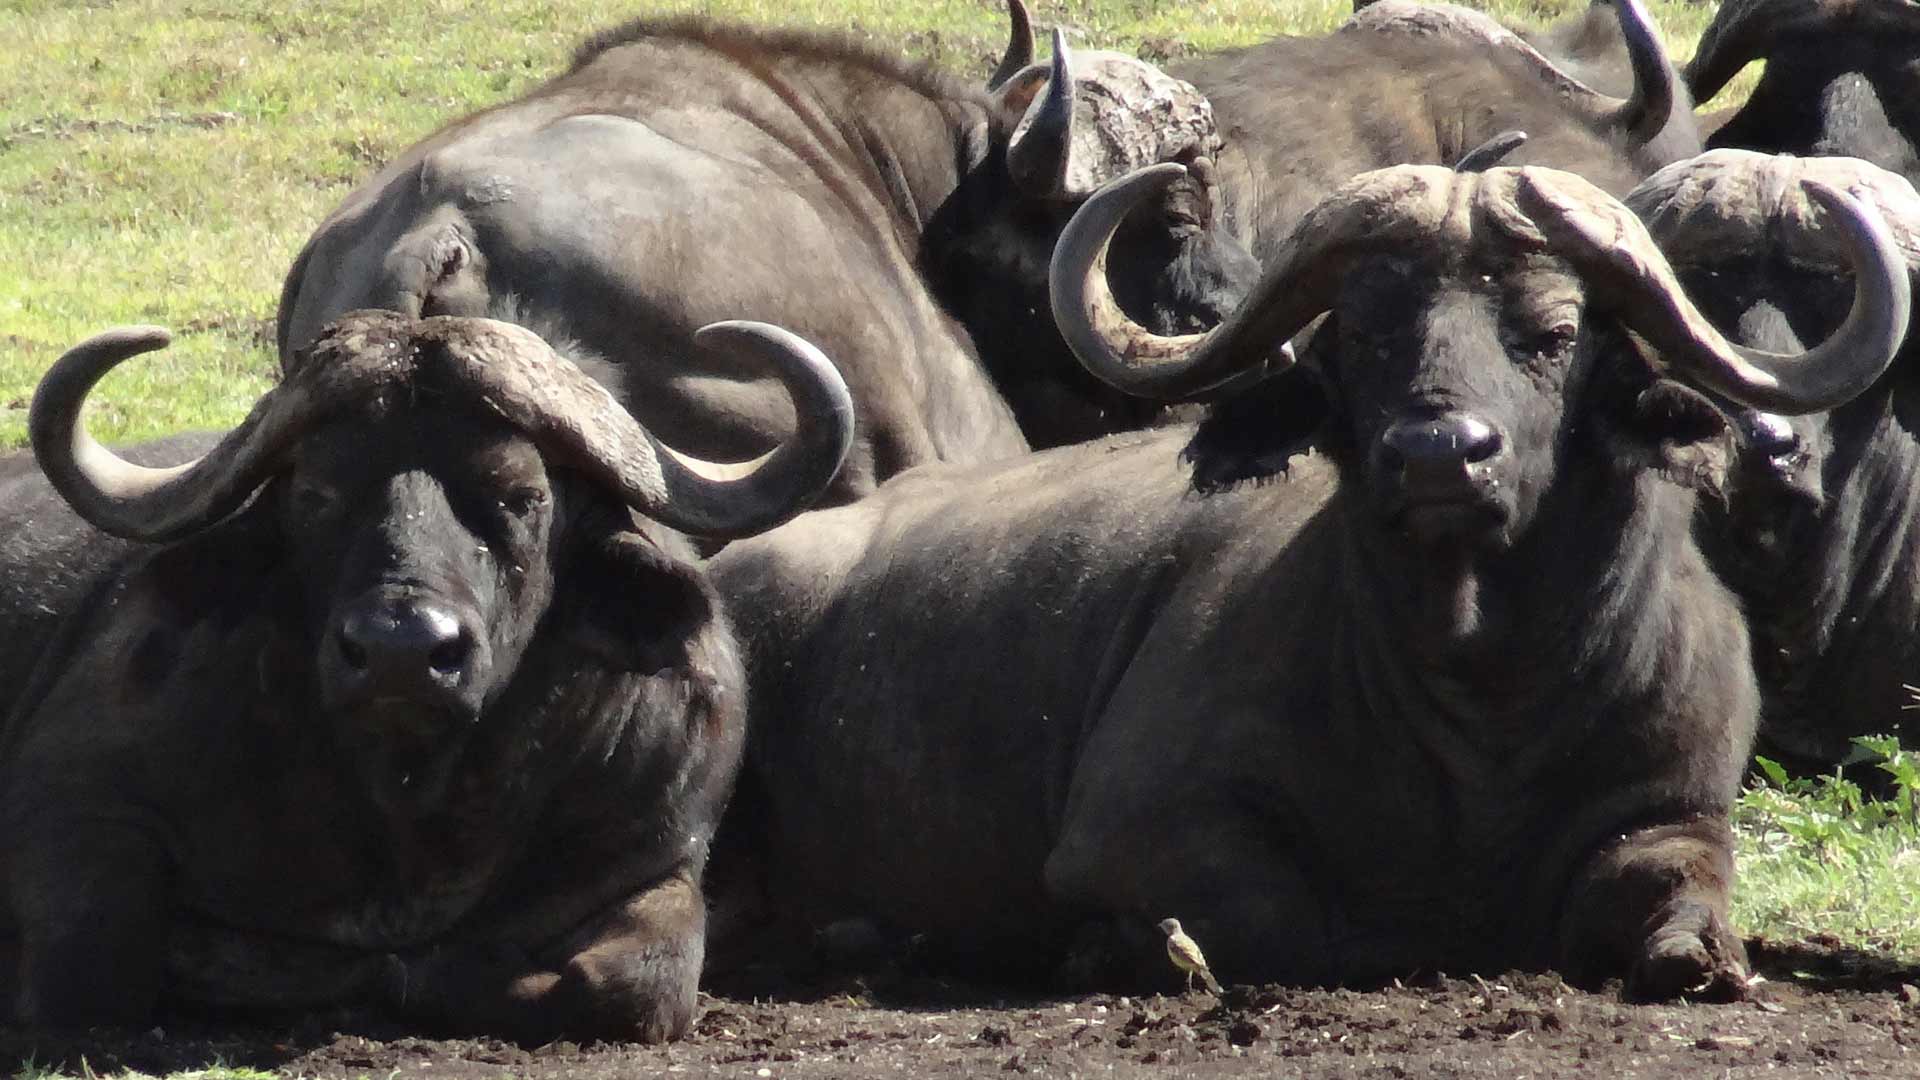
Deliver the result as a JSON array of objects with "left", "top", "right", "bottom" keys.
[{"left": 1686, "top": 0, "right": 1920, "bottom": 183}]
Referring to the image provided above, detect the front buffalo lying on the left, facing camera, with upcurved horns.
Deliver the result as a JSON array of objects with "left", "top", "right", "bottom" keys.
[{"left": 0, "top": 311, "right": 852, "bottom": 1040}]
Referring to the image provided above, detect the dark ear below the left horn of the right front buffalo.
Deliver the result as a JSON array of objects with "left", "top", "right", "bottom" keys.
[{"left": 1181, "top": 365, "right": 1331, "bottom": 494}]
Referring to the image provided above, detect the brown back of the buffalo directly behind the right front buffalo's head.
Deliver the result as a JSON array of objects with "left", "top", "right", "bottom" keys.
[{"left": 1173, "top": 6, "right": 1699, "bottom": 261}]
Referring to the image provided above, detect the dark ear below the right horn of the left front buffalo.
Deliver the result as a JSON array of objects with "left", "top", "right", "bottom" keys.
[{"left": 559, "top": 530, "right": 720, "bottom": 673}]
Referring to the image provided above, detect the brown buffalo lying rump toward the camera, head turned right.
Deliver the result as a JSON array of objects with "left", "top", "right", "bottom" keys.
[{"left": 278, "top": 0, "right": 1258, "bottom": 480}]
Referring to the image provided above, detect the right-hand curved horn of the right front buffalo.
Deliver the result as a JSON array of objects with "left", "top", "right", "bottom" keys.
[{"left": 1521, "top": 177, "right": 1912, "bottom": 415}]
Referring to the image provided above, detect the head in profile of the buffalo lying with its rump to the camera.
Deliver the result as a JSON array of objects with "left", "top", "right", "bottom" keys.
[{"left": 922, "top": 0, "right": 1260, "bottom": 446}]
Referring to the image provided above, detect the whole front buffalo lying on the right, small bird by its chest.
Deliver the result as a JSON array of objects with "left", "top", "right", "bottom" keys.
[{"left": 712, "top": 159, "right": 1908, "bottom": 997}]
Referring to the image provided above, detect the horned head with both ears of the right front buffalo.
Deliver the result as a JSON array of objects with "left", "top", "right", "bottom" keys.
[{"left": 1054, "top": 165, "right": 1908, "bottom": 548}]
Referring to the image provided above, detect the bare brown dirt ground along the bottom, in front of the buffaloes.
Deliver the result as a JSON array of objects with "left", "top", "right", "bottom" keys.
[{"left": 0, "top": 940, "right": 1920, "bottom": 1080}]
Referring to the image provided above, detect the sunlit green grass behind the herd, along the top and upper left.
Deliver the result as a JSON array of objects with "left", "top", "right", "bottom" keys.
[{"left": 0, "top": 0, "right": 1743, "bottom": 450}]
